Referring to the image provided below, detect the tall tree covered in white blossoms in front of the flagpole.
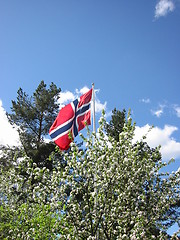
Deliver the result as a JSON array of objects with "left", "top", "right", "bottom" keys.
[{"left": 60, "top": 111, "right": 180, "bottom": 239}]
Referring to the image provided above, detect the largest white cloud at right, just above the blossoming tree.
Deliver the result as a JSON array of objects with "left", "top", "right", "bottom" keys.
[{"left": 134, "top": 124, "right": 180, "bottom": 161}]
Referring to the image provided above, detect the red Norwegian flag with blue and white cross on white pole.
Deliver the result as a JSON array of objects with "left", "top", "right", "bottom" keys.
[{"left": 49, "top": 89, "right": 92, "bottom": 150}]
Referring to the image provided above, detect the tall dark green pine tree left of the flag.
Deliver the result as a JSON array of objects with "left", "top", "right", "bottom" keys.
[{"left": 7, "top": 80, "right": 61, "bottom": 170}]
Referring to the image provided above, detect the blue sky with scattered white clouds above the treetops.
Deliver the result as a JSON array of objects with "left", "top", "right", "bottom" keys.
[{"left": 0, "top": 0, "right": 180, "bottom": 234}]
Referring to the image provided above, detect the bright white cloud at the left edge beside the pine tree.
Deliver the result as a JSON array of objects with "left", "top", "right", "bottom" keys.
[{"left": 0, "top": 100, "right": 20, "bottom": 146}]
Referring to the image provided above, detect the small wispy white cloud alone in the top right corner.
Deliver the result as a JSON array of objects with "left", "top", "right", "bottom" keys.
[{"left": 155, "top": 0, "right": 175, "bottom": 18}]
